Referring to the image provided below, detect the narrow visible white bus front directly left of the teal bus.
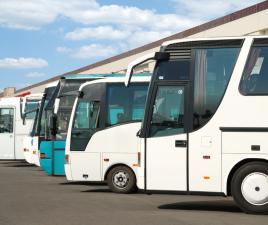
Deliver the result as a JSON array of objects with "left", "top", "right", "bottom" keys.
[{"left": 24, "top": 81, "right": 58, "bottom": 166}]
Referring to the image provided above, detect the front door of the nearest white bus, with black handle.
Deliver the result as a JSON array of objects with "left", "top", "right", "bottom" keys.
[{"left": 145, "top": 82, "right": 189, "bottom": 191}]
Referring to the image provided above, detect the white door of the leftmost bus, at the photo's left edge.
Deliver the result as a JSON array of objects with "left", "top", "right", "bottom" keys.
[{"left": 0, "top": 107, "right": 16, "bottom": 159}]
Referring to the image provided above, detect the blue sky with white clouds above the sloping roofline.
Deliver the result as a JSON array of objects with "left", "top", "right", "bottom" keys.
[{"left": 0, "top": 0, "right": 262, "bottom": 91}]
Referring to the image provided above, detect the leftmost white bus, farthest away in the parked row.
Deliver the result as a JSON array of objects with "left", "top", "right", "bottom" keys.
[{"left": 0, "top": 95, "right": 40, "bottom": 159}]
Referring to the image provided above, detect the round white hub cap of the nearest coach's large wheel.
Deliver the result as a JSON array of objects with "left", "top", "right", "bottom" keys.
[{"left": 241, "top": 172, "right": 268, "bottom": 205}]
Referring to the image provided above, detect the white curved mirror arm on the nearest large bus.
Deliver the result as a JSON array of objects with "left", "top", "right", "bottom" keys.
[{"left": 125, "top": 52, "right": 169, "bottom": 87}]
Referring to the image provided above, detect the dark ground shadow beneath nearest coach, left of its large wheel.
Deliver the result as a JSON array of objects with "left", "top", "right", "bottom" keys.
[{"left": 158, "top": 200, "right": 242, "bottom": 213}]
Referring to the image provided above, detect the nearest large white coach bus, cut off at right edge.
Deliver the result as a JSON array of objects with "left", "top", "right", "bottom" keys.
[{"left": 126, "top": 36, "right": 268, "bottom": 213}]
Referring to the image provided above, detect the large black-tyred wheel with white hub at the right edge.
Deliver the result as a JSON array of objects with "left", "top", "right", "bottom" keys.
[{"left": 231, "top": 162, "right": 268, "bottom": 214}]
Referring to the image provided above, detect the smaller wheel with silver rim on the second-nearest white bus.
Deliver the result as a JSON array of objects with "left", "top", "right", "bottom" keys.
[{"left": 107, "top": 166, "right": 137, "bottom": 194}]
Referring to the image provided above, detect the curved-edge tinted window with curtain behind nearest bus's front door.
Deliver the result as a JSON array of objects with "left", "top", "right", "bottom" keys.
[{"left": 193, "top": 48, "right": 240, "bottom": 129}]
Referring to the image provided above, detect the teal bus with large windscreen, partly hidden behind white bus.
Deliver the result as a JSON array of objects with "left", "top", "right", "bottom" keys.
[{"left": 40, "top": 74, "right": 119, "bottom": 175}]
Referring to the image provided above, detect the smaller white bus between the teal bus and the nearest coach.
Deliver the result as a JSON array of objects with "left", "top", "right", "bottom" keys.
[{"left": 65, "top": 74, "right": 150, "bottom": 193}]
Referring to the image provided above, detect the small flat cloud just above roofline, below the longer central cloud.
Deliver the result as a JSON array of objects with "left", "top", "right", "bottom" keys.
[{"left": 57, "top": 44, "right": 118, "bottom": 59}]
